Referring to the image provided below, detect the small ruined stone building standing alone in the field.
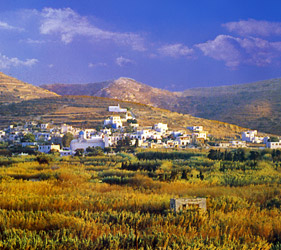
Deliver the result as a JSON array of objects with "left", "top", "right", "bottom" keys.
[{"left": 170, "top": 198, "right": 207, "bottom": 212}]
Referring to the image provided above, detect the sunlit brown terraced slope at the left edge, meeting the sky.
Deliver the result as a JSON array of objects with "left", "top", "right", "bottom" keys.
[{"left": 0, "top": 72, "right": 58, "bottom": 103}]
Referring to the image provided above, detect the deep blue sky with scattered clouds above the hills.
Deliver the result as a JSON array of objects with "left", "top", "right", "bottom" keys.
[{"left": 0, "top": 0, "right": 281, "bottom": 90}]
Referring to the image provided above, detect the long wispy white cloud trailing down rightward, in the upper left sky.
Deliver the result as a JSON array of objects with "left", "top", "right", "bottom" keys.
[{"left": 40, "top": 8, "right": 145, "bottom": 51}]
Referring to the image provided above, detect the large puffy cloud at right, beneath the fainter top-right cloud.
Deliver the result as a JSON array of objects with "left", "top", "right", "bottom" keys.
[{"left": 195, "top": 35, "right": 281, "bottom": 68}]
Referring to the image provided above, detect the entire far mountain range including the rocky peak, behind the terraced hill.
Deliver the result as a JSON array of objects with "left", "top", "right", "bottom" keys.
[{"left": 40, "top": 78, "right": 281, "bottom": 135}]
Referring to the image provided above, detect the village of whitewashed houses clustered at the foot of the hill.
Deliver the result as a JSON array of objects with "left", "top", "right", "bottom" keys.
[{"left": 0, "top": 104, "right": 281, "bottom": 156}]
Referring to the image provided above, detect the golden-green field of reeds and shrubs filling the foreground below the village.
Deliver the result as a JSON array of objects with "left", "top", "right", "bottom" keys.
[{"left": 0, "top": 148, "right": 281, "bottom": 250}]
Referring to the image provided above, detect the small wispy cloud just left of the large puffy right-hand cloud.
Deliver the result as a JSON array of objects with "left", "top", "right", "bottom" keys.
[{"left": 158, "top": 43, "right": 193, "bottom": 57}]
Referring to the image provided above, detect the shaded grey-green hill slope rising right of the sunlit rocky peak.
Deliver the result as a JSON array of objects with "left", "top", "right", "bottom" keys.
[{"left": 174, "top": 79, "right": 281, "bottom": 135}]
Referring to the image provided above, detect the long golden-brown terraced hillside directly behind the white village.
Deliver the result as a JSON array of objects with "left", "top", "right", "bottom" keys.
[{"left": 0, "top": 96, "right": 245, "bottom": 138}]
